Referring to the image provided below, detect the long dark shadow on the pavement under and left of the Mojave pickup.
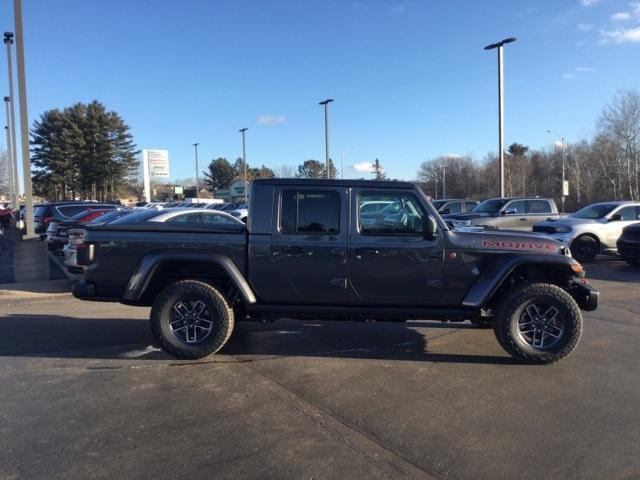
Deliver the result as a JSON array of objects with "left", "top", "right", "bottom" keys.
[{"left": 0, "top": 314, "right": 515, "bottom": 365}]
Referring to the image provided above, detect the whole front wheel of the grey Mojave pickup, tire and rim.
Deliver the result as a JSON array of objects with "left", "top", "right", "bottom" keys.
[{"left": 493, "top": 283, "right": 582, "bottom": 364}]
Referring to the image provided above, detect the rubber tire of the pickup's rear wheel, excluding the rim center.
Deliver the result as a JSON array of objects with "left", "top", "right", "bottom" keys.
[{"left": 150, "top": 280, "right": 234, "bottom": 359}]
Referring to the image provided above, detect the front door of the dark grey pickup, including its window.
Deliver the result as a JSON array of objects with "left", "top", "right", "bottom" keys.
[{"left": 349, "top": 189, "right": 444, "bottom": 306}]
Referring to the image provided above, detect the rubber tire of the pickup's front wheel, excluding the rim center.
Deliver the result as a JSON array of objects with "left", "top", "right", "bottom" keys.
[{"left": 493, "top": 283, "right": 582, "bottom": 364}]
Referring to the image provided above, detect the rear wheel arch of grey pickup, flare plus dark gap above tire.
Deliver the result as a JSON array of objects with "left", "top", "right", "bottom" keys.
[{"left": 122, "top": 252, "right": 256, "bottom": 304}]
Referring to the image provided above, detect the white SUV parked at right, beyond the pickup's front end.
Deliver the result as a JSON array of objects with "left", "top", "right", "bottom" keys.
[{"left": 533, "top": 202, "right": 640, "bottom": 263}]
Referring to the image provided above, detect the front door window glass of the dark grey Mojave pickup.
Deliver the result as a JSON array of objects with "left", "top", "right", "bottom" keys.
[{"left": 358, "top": 193, "right": 423, "bottom": 235}]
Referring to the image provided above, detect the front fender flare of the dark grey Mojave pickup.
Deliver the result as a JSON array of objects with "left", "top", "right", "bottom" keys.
[{"left": 462, "top": 254, "right": 584, "bottom": 308}]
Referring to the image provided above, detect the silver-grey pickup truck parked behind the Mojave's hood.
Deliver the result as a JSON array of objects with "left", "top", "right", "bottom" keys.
[{"left": 443, "top": 197, "right": 559, "bottom": 231}]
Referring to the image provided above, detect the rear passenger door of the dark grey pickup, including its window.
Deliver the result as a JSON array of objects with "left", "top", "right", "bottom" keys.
[{"left": 271, "top": 187, "right": 349, "bottom": 304}]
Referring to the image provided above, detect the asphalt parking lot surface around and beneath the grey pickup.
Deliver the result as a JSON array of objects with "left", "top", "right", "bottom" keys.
[{"left": 0, "top": 260, "right": 640, "bottom": 479}]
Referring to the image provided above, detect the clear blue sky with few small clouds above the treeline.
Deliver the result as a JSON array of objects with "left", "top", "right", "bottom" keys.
[{"left": 5, "top": 0, "right": 640, "bottom": 184}]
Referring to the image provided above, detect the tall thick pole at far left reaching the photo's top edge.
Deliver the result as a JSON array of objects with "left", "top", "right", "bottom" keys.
[{"left": 13, "top": 0, "right": 35, "bottom": 238}]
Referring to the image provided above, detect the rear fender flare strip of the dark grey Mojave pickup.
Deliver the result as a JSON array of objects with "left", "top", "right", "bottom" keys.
[{"left": 122, "top": 252, "right": 256, "bottom": 304}]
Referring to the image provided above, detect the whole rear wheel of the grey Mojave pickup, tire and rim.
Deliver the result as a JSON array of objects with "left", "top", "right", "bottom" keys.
[{"left": 151, "top": 280, "right": 234, "bottom": 358}]
